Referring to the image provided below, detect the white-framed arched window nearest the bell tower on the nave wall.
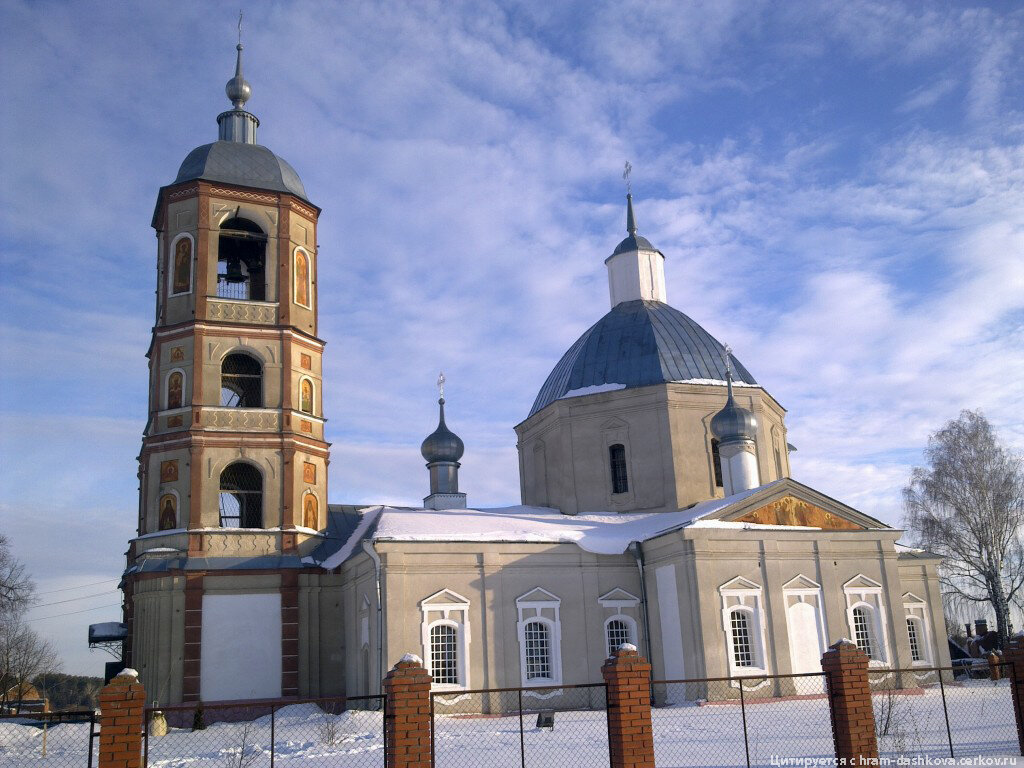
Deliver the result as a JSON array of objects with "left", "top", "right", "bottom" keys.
[{"left": 420, "top": 589, "right": 470, "bottom": 690}]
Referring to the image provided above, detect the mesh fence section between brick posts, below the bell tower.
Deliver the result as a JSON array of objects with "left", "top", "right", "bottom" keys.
[{"left": 142, "top": 695, "right": 385, "bottom": 768}]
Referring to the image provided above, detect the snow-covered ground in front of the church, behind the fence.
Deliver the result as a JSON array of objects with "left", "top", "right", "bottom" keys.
[{"left": 0, "top": 681, "right": 1018, "bottom": 768}]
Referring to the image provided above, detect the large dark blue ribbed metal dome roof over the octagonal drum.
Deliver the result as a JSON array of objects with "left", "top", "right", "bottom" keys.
[{"left": 529, "top": 300, "right": 757, "bottom": 416}]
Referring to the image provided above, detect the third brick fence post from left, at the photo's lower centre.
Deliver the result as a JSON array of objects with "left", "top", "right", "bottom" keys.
[{"left": 601, "top": 643, "right": 654, "bottom": 768}]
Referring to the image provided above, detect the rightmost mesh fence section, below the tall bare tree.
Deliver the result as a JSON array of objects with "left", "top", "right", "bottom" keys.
[{"left": 867, "top": 663, "right": 1020, "bottom": 758}]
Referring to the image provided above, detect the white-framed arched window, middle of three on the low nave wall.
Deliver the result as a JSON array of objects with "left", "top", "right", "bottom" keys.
[{"left": 515, "top": 587, "right": 562, "bottom": 686}]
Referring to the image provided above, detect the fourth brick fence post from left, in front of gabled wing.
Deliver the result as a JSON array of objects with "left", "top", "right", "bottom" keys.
[{"left": 821, "top": 640, "right": 879, "bottom": 765}]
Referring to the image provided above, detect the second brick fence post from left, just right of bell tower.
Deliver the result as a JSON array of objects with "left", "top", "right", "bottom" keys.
[{"left": 384, "top": 653, "right": 431, "bottom": 768}]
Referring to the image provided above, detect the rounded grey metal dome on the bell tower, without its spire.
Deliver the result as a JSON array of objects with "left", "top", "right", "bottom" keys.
[{"left": 174, "top": 141, "right": 308, "bottom": 200}]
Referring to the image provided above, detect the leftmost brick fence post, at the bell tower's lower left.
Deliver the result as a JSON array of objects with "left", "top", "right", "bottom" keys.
[{"left": 98, "top": 670, "right": 145, "bottom": 768}]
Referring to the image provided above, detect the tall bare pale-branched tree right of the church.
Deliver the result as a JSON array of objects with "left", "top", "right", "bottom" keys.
[{"left": 903, "top": 411, "right": 1024, "bottom": 645}]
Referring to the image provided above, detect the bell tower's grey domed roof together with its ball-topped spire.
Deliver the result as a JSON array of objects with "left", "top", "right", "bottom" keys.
[{"left": 174, "top": 43, "right": 308, "bottom": 200}]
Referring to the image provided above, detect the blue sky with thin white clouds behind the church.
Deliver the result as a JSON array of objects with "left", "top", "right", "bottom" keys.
[{"left": 0, "top": 0, "right": 1024, "bottom": 674}]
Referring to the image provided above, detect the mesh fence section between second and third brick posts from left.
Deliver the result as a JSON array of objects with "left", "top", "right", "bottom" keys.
[{"left": 430, "top": 683, "right": 610, "bottom": 768}]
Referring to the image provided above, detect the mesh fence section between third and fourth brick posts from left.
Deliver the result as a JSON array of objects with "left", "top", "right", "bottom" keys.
[{"left": 651, "top": 673, "right": 836, "bottom": 768}]
